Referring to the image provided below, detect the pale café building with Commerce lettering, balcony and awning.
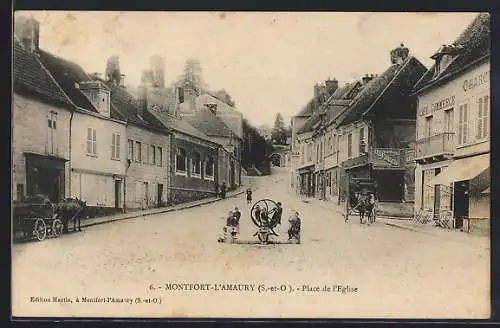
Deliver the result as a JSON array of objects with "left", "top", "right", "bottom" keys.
[{"left": 414, "top": 14, "right": 491, "bottom": 231}]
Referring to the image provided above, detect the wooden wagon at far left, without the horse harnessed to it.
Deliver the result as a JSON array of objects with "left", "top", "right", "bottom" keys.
[{"left": 13, "top": 196, "right": 63, "bottom": 241}]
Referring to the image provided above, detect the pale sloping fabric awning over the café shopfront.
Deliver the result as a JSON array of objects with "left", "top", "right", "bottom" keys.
[{"left": 429, "top": 153, "right": 490, "bottom": 185}]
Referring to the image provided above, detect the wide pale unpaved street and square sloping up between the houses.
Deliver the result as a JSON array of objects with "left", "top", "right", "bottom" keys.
[{"left": 12, "top": 168, "right": 490, "bottom": 318}]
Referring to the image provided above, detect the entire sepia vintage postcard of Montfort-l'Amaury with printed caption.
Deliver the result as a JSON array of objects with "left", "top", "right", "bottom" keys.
[{"left": 11, "top": 11, "right": 492, "bottom": 319}]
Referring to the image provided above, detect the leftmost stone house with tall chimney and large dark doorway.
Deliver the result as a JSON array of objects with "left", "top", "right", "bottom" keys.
[{"left": 11, "top": 34, "right": 74, "bottom": 201}]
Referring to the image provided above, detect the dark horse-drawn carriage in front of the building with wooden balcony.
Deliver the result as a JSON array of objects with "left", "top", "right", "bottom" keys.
[{"left": 344, "top": 178, "right": 378, "bottom": 224}]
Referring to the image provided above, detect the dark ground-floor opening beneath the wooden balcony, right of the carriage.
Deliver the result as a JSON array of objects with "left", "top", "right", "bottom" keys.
[{"left": 373, "top": 170, "right": 405, "bottom": 203}]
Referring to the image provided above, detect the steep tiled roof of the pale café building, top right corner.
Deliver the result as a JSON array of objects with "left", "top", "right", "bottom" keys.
[{"left": 413, "top": 13, "right": 491, "bottom": 92}]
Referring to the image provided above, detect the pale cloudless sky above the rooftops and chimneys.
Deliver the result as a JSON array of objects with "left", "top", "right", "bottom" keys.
[{"left": 16, "top": 11, "right": 476, "bottom": 126}]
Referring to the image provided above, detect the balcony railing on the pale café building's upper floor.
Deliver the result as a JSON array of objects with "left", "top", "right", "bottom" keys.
[{"left": 415, "top": 132, "right": 455, "bottom": 160}]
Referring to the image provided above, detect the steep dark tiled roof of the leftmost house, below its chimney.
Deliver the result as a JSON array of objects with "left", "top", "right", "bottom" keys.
[{"left": 13, "top": 39, "right": 73, "bottom": 107}]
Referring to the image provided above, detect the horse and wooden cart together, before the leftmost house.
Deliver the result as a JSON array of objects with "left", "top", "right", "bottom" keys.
[{"left": 13, "top": 195, "right": 85, "bottom": 241}]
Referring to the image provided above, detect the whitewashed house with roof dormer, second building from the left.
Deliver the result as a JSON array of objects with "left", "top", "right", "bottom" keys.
[{"left": 38, "top": 43, "right": 127, "bottom": 213}]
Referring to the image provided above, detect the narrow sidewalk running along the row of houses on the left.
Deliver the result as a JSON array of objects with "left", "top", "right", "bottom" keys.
[{"left": 82, "top": 188, "right": 246, "bottom": 228}]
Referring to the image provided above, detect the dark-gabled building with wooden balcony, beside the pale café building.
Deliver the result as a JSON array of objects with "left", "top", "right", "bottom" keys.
[{"left": 334, "top": 45, "right": 427, "bottom": 203}]
